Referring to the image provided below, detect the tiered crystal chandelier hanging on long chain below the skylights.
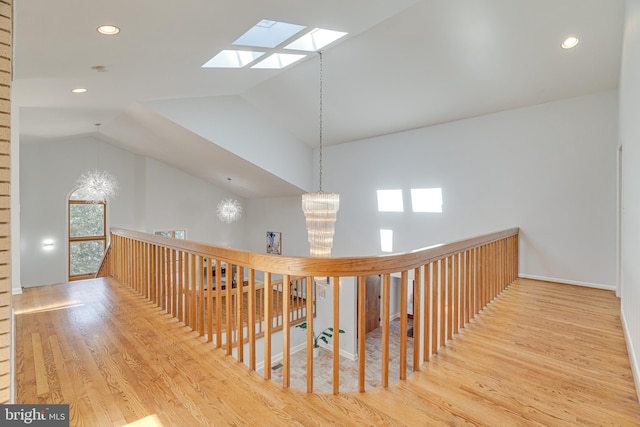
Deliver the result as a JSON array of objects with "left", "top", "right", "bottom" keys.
[{"left": 302, "top": 51, "right": 340, "bottom": 262}]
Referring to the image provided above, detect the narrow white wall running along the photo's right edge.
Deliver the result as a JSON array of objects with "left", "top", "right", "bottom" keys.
[{"left": 620, "top": 0, "right": 640, "bottom": 398}]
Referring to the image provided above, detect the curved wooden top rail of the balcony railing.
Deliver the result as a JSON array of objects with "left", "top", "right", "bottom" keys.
[{"left": 111, "top": 227, "right": 520, "bottom": 276}]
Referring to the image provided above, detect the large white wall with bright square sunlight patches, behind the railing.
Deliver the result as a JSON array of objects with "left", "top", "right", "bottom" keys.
[{"left": 324, "top": 91, "right": 618, "bottom": 289}]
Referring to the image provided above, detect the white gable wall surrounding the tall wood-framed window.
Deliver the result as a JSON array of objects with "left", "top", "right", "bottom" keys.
[{"left": 20, "top": 136, "right": 136, "bottom": 287}]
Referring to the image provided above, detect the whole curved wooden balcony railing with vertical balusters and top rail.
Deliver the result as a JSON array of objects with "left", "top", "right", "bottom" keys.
[{"left": 98, "top": 228, "right": 519, "bottom": 394}]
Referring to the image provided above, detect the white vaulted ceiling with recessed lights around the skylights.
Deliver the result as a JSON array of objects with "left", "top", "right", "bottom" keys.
[{"left": 12, "top": 0, "right": 624, "bottom": 197}]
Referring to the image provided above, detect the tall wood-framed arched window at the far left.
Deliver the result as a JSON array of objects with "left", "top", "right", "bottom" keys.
[{"left": 69, "top": 190, "right": 107, "bottom": 281}]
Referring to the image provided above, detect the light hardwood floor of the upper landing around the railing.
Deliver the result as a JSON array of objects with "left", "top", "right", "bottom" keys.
[{"left": 13, "top": 279, "right": 640, "bottom": 426}]
